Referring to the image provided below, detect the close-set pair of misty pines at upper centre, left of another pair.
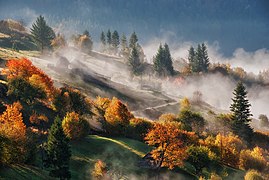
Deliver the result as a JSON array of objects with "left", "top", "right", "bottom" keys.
[{"left": 153, "top": 44, "right": 174, "bottom": 76}]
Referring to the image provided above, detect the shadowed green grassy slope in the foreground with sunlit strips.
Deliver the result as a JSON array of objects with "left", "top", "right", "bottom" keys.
[{"left": 0, "top": 135, "right": 195, "bottom": 179}]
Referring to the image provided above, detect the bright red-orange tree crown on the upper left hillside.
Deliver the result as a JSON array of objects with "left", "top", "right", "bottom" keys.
[{"left": 3, "top": 58, "right": 55, "bottom": 97}]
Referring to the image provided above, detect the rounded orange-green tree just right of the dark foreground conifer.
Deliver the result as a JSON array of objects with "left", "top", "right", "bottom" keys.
[{"left": 62, "top": 112, "right": 89, "bottom": 140}]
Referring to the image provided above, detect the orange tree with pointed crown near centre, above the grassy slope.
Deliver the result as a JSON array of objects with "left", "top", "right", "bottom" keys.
[{"left": 104, "top": 97, "right": 134, "bottom": 134}]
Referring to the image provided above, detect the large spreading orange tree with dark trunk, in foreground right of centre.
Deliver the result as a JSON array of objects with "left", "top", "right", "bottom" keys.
[{"left": 145, "top": 123, "right": 187, "bottom": 169}]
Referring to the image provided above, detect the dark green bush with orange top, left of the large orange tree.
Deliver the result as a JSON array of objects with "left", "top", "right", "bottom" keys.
[{"left": 126, "top": 118, "right": 152, "bottom": 141}]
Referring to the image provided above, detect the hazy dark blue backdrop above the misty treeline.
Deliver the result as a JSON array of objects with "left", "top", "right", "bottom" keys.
[{"left": 0, "top": 0, "right": 269, "bottom": 56}]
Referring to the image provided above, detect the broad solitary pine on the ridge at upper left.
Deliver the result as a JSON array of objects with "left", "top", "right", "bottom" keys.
[{"left": 30, "top": 15, "right": 55, "bottom": 52}]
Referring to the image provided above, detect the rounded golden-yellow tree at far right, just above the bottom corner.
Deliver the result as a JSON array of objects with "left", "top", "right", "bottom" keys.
[{"left": 239, "top": 147, "right": 268, "bottom": 172}]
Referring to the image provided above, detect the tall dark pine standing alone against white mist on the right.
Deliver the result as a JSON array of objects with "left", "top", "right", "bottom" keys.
[{"left": 230, "top": 82, "right": 253, "bottom": 142}]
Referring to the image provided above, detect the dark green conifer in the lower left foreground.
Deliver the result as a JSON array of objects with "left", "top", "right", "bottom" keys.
[{"left": 44, "top": 117, "right": 71, "bottom": 179}]
